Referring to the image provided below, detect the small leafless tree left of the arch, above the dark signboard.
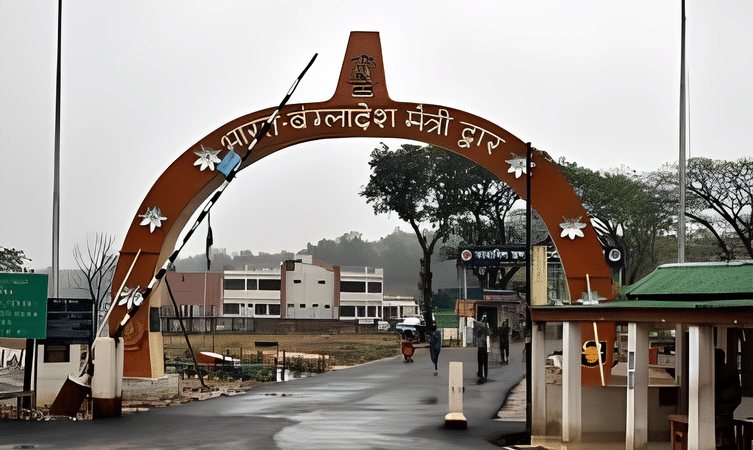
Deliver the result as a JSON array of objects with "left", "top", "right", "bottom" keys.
[{"left": 73, "top": 233, "right": 118, "bottom": 328}]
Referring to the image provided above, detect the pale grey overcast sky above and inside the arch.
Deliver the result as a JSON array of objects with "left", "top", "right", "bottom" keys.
[{"left": 0, "top": 0, "right": 753, "bottom": 269}]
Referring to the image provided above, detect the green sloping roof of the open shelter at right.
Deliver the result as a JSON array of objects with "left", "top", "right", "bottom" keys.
[{"left": 625, "top": 261, "right": 753, "bottom": 298}]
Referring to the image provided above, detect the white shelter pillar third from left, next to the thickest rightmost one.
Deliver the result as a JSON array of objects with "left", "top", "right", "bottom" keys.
[{"left": 625, "top": 323, "right": 648, "bottom": 450}]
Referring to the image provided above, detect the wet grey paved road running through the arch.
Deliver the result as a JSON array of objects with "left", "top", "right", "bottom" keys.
[{"left": 0, "top": 344, "right": 525, "bottom": 450}]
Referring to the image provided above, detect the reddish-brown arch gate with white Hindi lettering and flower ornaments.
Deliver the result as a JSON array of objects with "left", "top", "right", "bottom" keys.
[{"left": 109, "top": 32, "right": 614, "bottom": 378}]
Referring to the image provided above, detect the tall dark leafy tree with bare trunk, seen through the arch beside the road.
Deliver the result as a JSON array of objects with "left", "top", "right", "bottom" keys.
[{"left": 360, "top": 144, "right": 464, "bottom": 329}]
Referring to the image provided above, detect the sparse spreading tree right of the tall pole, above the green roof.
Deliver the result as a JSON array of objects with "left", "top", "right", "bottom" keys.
[{"left": 685, "top": 158, "right": 753, "bottom": 261}]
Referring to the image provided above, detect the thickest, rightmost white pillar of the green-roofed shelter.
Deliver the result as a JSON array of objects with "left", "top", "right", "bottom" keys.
[{"left": 688, "top": 326, "right": 716, "bottom": 450}]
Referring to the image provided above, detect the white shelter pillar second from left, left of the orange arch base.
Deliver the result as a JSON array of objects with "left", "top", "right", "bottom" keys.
[{"left": 562, "top": 322, "right": 582, "bottom": 442}]
